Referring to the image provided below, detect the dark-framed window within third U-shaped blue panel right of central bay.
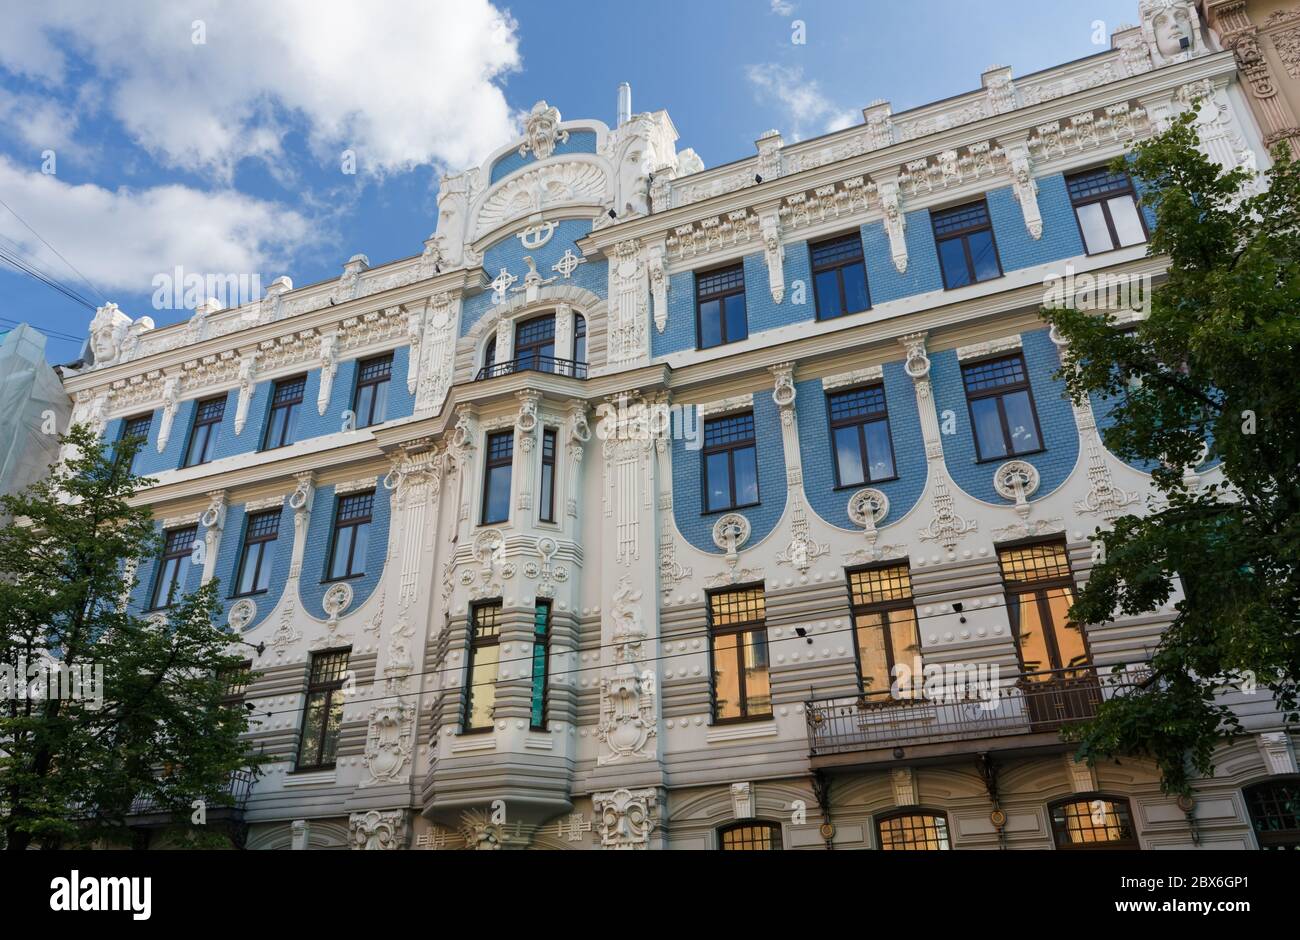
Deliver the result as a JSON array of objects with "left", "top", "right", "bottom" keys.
[{"left": 962, "top": 354, "right": 1043, "bottom": 460}]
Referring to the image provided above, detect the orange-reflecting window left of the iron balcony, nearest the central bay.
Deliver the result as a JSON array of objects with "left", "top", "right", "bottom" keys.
[{"left": 709, "top": 585, "right": 772, "bottom": 723}]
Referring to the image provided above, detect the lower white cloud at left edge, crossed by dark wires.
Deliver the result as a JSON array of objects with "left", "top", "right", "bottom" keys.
[{"left": 0, "top": 156, "right": 317, "bottom": 297}]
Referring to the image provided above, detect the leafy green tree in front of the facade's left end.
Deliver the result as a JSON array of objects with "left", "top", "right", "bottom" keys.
[{"left": 0, "top": 425, "right": 259, "bottom": 850}]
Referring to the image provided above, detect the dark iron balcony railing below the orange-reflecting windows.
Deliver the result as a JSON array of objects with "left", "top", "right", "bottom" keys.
[{"left": 805, "top": 668, "right": 1148, "bottom": 757}]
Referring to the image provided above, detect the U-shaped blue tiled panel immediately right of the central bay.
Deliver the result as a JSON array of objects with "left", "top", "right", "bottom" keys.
[{"left": 672, "top": 391, "right": 787, "bottom": 554}]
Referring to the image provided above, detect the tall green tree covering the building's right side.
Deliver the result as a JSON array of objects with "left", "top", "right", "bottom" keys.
[{"left": 1044, "top": 113, "right": 1300, "bottom": 793}]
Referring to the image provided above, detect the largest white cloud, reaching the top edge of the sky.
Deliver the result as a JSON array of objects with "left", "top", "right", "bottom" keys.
[{"left": 0, "top": 0, "right": 520, "bottom": 179}]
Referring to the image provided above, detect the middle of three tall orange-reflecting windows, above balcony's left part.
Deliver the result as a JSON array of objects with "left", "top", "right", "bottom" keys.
[{"left": 849, "top": 564, "right": 922, "bottom": 698}]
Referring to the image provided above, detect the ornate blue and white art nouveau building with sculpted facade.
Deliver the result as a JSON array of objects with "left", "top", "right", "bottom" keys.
[{"left": 68, "top": 0, "right": 1296, "bottom": 849}]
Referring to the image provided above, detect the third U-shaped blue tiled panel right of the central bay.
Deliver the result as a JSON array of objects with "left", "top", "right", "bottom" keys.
[{"left": 930, "top": 329, "right": 1079, "bottom": 506}]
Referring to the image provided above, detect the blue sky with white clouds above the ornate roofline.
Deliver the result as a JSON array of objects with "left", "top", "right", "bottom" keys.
[{"left": 0, "top": 0, "right": 1138, "bottom": 361}]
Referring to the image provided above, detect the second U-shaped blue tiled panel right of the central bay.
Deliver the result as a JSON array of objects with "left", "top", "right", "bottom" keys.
[{"left": 794, "top": 361, "right": 927, "bottom": 530}]
